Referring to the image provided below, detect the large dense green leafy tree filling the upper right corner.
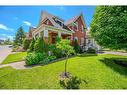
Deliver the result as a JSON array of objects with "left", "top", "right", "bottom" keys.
[{"left": 90, "top": 6, "right": 127, "bottom": 50}]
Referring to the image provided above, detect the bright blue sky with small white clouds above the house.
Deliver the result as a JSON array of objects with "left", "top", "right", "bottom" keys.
[{"left": 0, "top": 5, "right": 96, "bottom": 40}]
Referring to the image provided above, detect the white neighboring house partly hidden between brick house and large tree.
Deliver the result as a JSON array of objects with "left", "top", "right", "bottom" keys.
[{"left": 86, "top": 28, "right": 101, "bottom": 50}]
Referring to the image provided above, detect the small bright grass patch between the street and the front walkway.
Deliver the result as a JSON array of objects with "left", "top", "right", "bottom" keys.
[{"left": 1, "top": 52, "right": 27, "bottom": 64}]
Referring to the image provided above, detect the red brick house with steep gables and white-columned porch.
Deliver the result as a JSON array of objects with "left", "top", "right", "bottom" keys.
[{"left": 28, "top": 11, "right": 86, "bottom": 47}]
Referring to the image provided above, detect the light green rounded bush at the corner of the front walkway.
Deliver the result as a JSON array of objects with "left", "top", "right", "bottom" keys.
[{"left": 25, "top": 52, "right": 45, "bottom": 65}]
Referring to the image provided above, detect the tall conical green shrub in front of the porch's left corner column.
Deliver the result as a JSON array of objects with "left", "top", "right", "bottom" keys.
[{"left": 34, "top": 37, "right": 47, "bottom": 53}]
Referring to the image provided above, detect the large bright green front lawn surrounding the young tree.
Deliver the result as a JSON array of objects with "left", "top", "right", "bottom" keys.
[{"left": 0, "top": 55, "right": 127, "bottom": 89}]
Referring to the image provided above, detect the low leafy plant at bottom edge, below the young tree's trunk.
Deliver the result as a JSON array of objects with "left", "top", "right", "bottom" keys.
[{"left": 59, "top": 76, "right": 88, "bottom": 89}]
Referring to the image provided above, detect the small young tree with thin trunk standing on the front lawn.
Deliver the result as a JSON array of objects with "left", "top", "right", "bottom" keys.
[{"left": 56, "top": 40, "right": 75, "bottom": 77}]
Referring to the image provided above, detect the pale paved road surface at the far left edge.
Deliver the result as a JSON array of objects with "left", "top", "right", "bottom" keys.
[{"left": 0, "top": 45, "right": 12, "bottom": 63}]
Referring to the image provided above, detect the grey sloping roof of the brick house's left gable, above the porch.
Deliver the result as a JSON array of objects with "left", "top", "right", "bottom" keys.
[{"left": 38, "top": 11, "right": 71, "bottom": 31}]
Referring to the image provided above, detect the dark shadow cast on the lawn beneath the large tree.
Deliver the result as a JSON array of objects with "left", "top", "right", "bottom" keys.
[{"left": 100, "top": 58, "right": 127, "bottom": 76}]
